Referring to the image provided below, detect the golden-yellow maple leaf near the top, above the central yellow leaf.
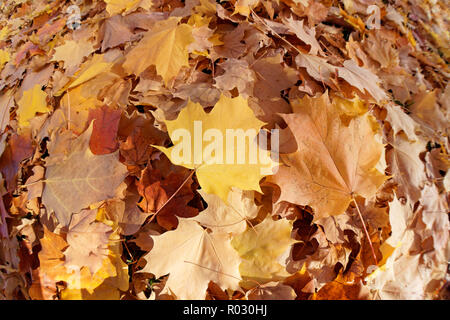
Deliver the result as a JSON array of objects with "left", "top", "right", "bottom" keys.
[{"left": 123, "top": 18, "right": 194, "bottom": 85}]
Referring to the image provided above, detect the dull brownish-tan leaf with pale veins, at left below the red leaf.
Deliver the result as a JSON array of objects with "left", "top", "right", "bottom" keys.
[{"left": 42, "top": 124, "right": 127, "bottom": 226}]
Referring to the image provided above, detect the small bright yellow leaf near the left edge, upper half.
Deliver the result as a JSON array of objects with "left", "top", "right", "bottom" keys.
[{"left": 17, "top": 84, "right": 50, "bottom": 127}]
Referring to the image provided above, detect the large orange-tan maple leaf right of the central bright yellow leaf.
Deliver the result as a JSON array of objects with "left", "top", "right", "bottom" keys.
[{"left": 269, "top": 94, "right": 386, "bottom": 219}]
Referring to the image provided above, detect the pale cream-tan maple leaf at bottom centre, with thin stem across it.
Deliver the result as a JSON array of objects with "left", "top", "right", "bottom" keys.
[{"left": 142, "top": 218, "right": 240, "bottom": 299}]
